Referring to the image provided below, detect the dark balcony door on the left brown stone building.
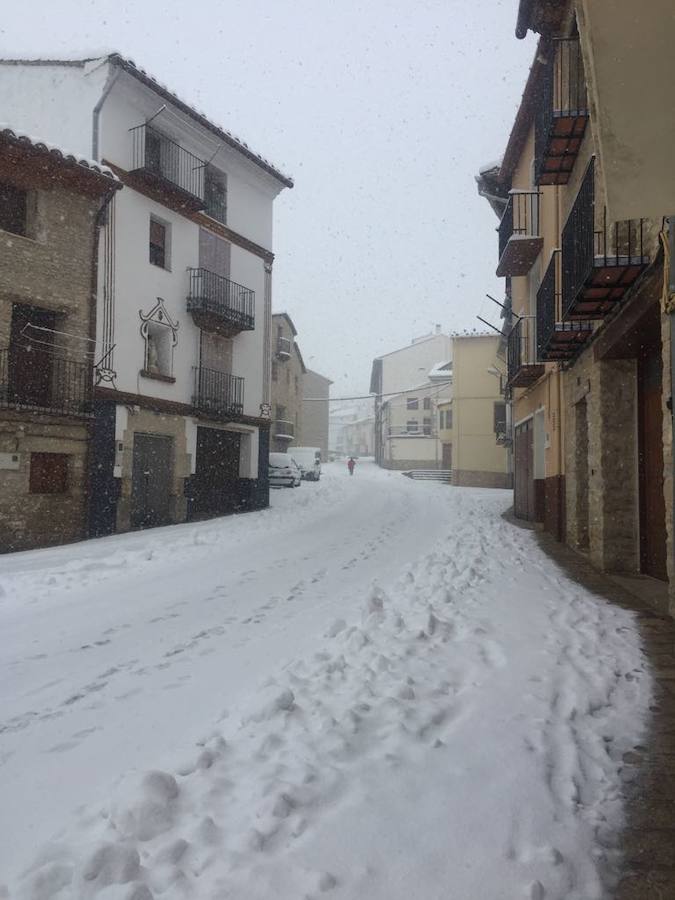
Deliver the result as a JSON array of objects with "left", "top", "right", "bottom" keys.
[{"left": 7, "top": 303, "right": 57, "bottom": 407}]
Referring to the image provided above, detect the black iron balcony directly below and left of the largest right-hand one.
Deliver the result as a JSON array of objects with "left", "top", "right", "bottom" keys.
[{"left": 537, "top": 250, "right": 593, "bottom": 361}]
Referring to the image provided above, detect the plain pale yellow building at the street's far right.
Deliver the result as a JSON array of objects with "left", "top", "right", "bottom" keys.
[{"left": 438, "top": 334, "right": 511, "bottom": 488}]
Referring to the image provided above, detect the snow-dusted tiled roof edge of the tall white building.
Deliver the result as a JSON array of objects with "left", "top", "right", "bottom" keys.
[{"left": 0, "top": 52, "right": 293, "bottom": 188}]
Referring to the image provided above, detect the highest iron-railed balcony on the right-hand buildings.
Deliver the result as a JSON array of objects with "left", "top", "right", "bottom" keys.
[{"left": 534, "top": 38, "right": 588, "bottom": 185}]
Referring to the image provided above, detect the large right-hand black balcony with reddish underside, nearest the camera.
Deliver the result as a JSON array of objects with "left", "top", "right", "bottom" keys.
[{"left": 562, "top": 157, "right": 649, "bottom": 320}]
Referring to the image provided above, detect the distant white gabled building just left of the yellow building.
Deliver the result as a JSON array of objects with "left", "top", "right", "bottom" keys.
[{"left": 370, "top": 327, "right": 452, "bottom": 470}]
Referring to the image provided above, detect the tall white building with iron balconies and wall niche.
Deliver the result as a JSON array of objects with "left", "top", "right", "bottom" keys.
[{"left": 0, "top": 54, "right": 292, "bottom": 534}]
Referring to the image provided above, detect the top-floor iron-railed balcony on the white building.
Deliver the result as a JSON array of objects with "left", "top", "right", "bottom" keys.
[{"left": 129, "top": 124, "right": 206, "bottom": 211}]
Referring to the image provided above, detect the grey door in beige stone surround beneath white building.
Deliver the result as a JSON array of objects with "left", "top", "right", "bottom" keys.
[{"left": 131, "top": 434, "right": 173, "bottom": 528}]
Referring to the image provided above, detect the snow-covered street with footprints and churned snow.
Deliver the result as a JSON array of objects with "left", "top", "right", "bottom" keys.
[{"left": 0, "top": 463, "right": 650, "bottom": 900}]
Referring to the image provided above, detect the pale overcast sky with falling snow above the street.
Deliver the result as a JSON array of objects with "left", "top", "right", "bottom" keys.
[{"left": 0, "top": 0, "right": 534, "bottom": 396}]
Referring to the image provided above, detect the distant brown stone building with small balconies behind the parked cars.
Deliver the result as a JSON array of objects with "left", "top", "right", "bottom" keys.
[{"left": 272, "top": 313, "right": 307, "bottom": 453}]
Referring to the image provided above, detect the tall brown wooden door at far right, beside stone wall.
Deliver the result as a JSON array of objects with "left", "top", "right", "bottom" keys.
[{"left": 638, "top": 343, "right": 668, "bottom": 581}]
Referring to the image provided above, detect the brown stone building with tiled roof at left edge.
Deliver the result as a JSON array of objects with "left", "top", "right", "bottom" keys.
[{"left": 0, "top": 128, "right": 121, "bottom": 551}]
